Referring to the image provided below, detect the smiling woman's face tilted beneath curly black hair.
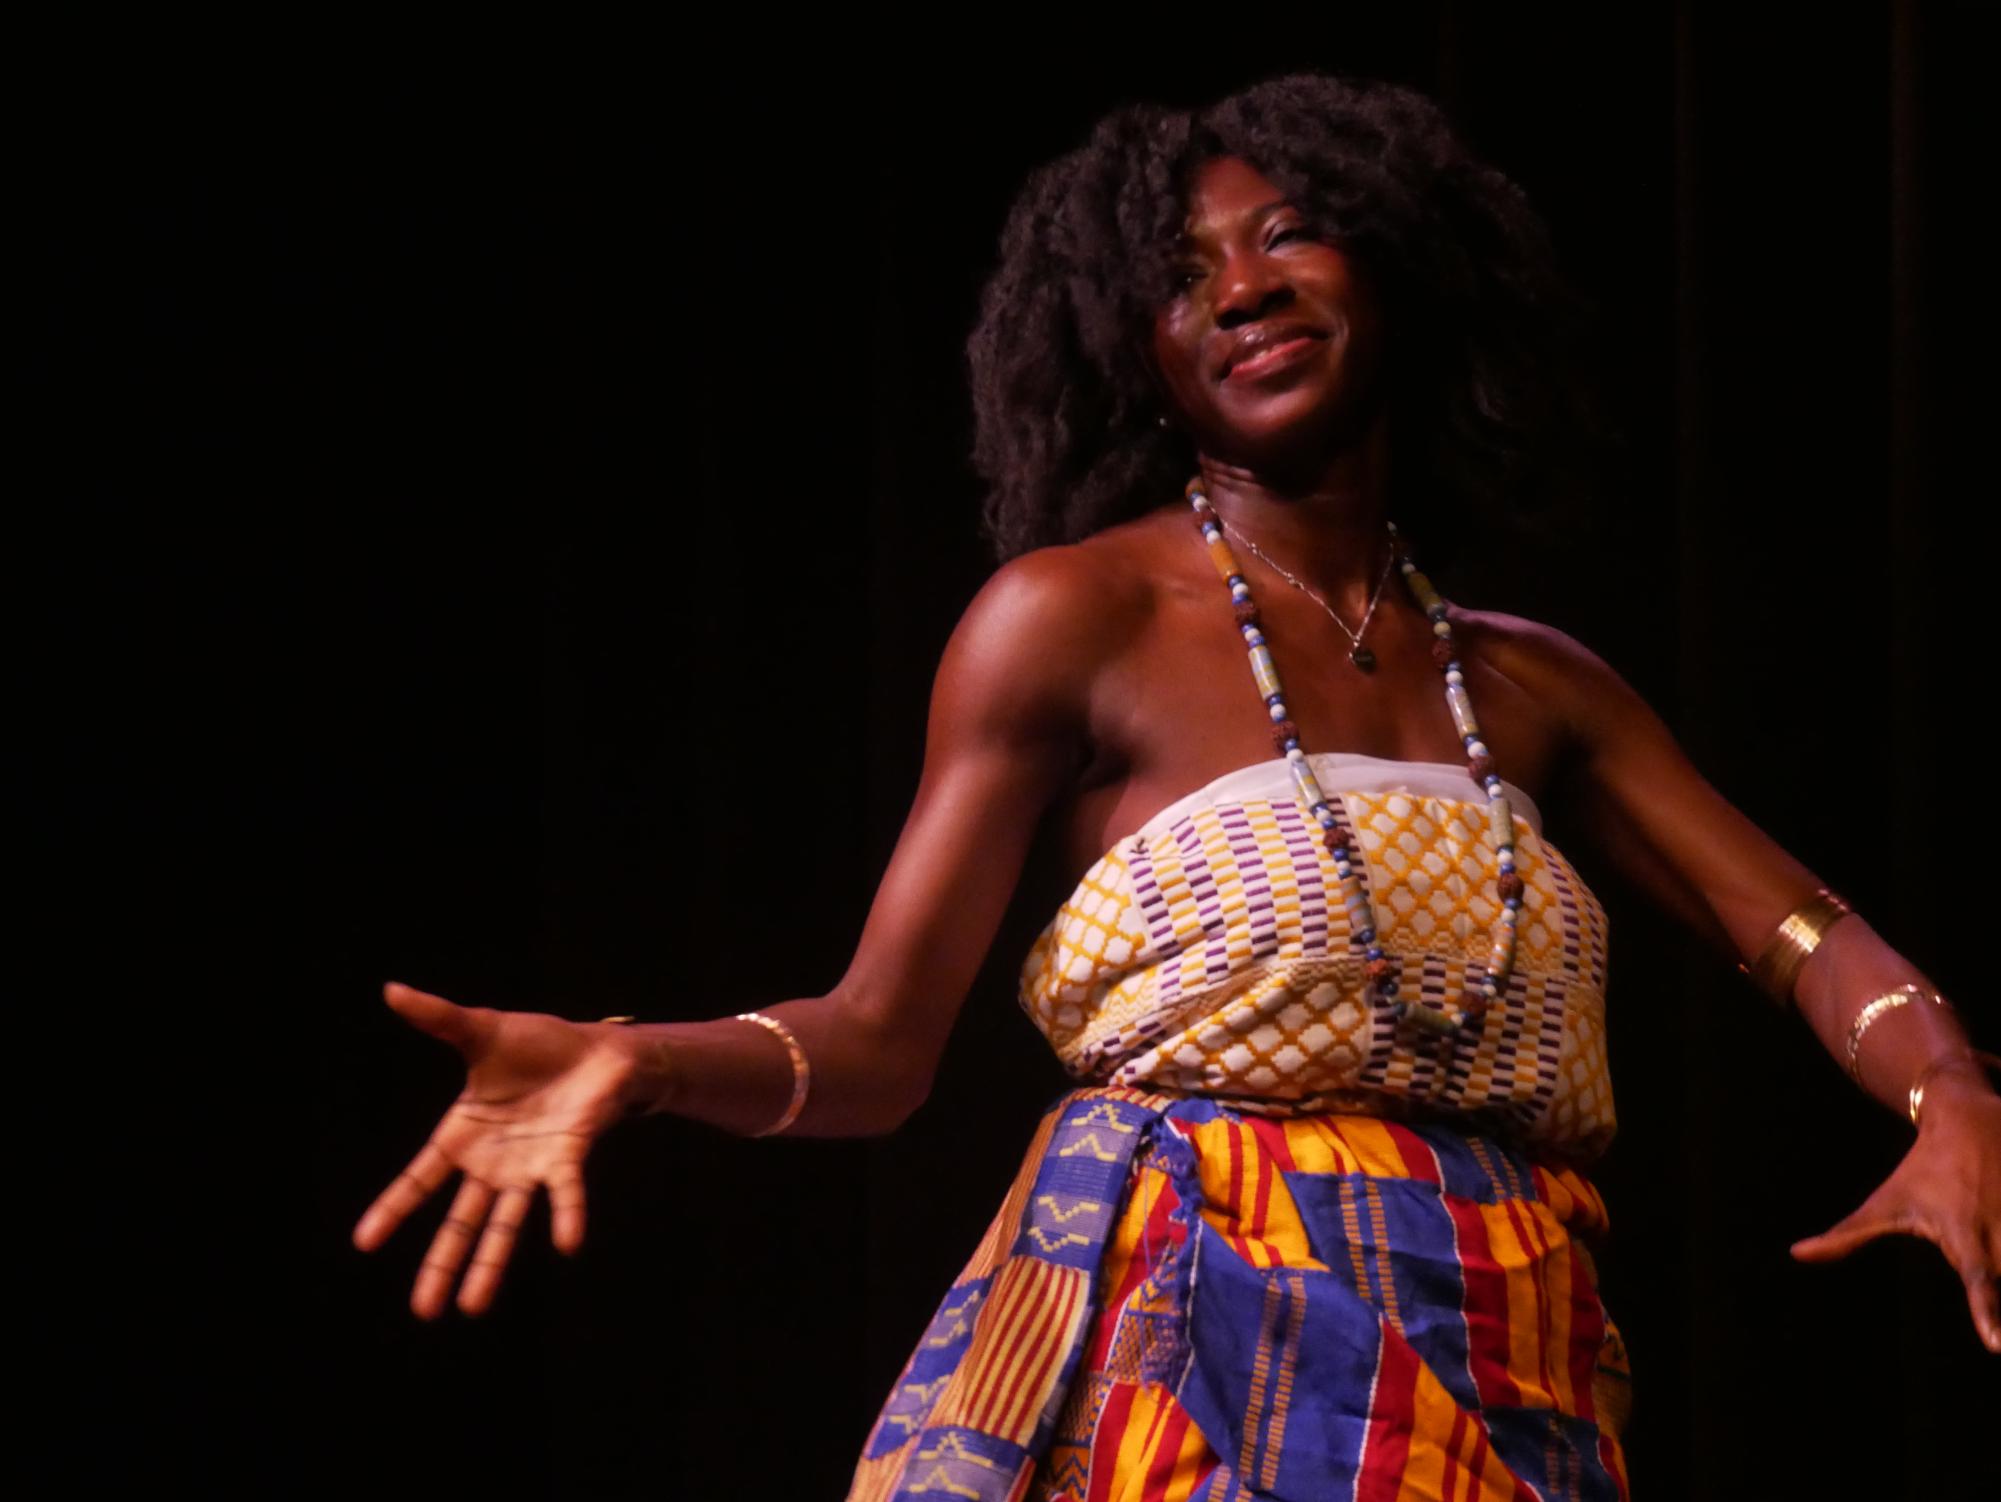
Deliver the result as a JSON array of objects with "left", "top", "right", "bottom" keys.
[{"left": 1153, "top": 156, "right": 1383, "bottom": 464}]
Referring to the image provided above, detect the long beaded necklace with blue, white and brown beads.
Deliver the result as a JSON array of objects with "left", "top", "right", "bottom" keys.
[{"left": 1187, "top": 476, "right": 1523, "bottom": 1036}]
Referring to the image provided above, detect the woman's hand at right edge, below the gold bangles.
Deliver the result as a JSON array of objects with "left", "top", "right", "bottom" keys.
[{"left": 1793, "top": 1074, "right": 2001, "bottom": 1352}]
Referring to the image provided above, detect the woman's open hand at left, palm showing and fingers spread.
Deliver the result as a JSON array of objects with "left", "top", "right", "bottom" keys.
[{"left": 354, "top": 982, "right": 634, "bottom": 1320}]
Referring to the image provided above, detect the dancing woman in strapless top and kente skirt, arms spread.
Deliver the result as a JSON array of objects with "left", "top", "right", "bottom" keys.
[{"left": 354, "top": 74, "right": 2001, "bottom": 1502}]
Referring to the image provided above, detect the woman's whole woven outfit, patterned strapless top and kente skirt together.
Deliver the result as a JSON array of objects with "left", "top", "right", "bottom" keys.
[{"left": 848, "top": 754, "right": 1629, "bottom": 1502}]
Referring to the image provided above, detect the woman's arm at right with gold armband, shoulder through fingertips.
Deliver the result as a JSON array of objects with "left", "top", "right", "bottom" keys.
[{"left": 1497, "top": 622, "right": 2001, "bottom": 1352}]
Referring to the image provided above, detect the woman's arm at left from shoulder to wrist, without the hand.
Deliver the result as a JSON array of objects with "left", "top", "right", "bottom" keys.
[{"left": 608, "top": 548, "right": 1105, "bottom": 1136}]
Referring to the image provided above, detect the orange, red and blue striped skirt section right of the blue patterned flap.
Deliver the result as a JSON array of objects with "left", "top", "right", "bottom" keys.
[{"left": 1025, "top": 1102, "right": 1631, "bottom": 1502}]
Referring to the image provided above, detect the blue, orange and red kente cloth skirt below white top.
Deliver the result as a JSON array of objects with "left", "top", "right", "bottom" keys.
[{"left": 848, "top": 1088, "right": 1631, "bottom": 1502}]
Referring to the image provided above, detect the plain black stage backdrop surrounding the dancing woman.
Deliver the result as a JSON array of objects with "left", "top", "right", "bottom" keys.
[{"left": 31, "top": 6, "right": 2001, "bottom": 1498}]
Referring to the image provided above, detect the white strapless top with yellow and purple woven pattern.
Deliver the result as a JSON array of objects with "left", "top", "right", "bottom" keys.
[{"left": 1021, "top": 752, "right": 1617, "bottom": 1162}]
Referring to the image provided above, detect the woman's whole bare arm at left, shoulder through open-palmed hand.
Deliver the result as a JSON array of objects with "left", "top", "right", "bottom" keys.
[{"left": 354, "top": 548, "right": 1115, "bottom": 1318}]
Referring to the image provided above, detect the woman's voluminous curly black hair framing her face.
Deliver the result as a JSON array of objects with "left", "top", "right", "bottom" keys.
[{"left": 966, "top": 72, "right": 1609, "bottom": 584}]
